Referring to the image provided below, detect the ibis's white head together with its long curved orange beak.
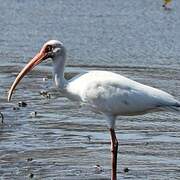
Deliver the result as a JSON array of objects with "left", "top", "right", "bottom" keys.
[{"left": 8, "top": 40, "right": 65, "bottom": 101}]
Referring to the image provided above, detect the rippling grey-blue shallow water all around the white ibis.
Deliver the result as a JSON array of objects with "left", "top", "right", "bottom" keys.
[{"left": 0, "top": 0, "right": 180, "bottom": 180}]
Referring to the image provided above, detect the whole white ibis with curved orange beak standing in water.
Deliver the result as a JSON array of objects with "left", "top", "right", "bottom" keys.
[{"left": 8, "top": 40, "right": 180, "bottom": 180}]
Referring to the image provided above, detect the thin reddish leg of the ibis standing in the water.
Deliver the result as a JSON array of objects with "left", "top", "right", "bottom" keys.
[{"left": 110, "top": 128, "right": 118, "bottom": 180}]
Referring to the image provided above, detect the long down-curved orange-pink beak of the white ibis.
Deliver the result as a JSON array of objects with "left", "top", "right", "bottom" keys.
[{"left": 8, "top": 51, "right": 48, "bottom": 101}]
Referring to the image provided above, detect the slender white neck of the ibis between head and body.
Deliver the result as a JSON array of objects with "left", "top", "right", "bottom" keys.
[{"left": 53, "top": 53, "right": 67, "bottom": 90}]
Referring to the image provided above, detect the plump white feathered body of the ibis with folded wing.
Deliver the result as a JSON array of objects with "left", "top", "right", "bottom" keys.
[{"left": 66, "top": 71, "right": 179, "bottom": 115}]
